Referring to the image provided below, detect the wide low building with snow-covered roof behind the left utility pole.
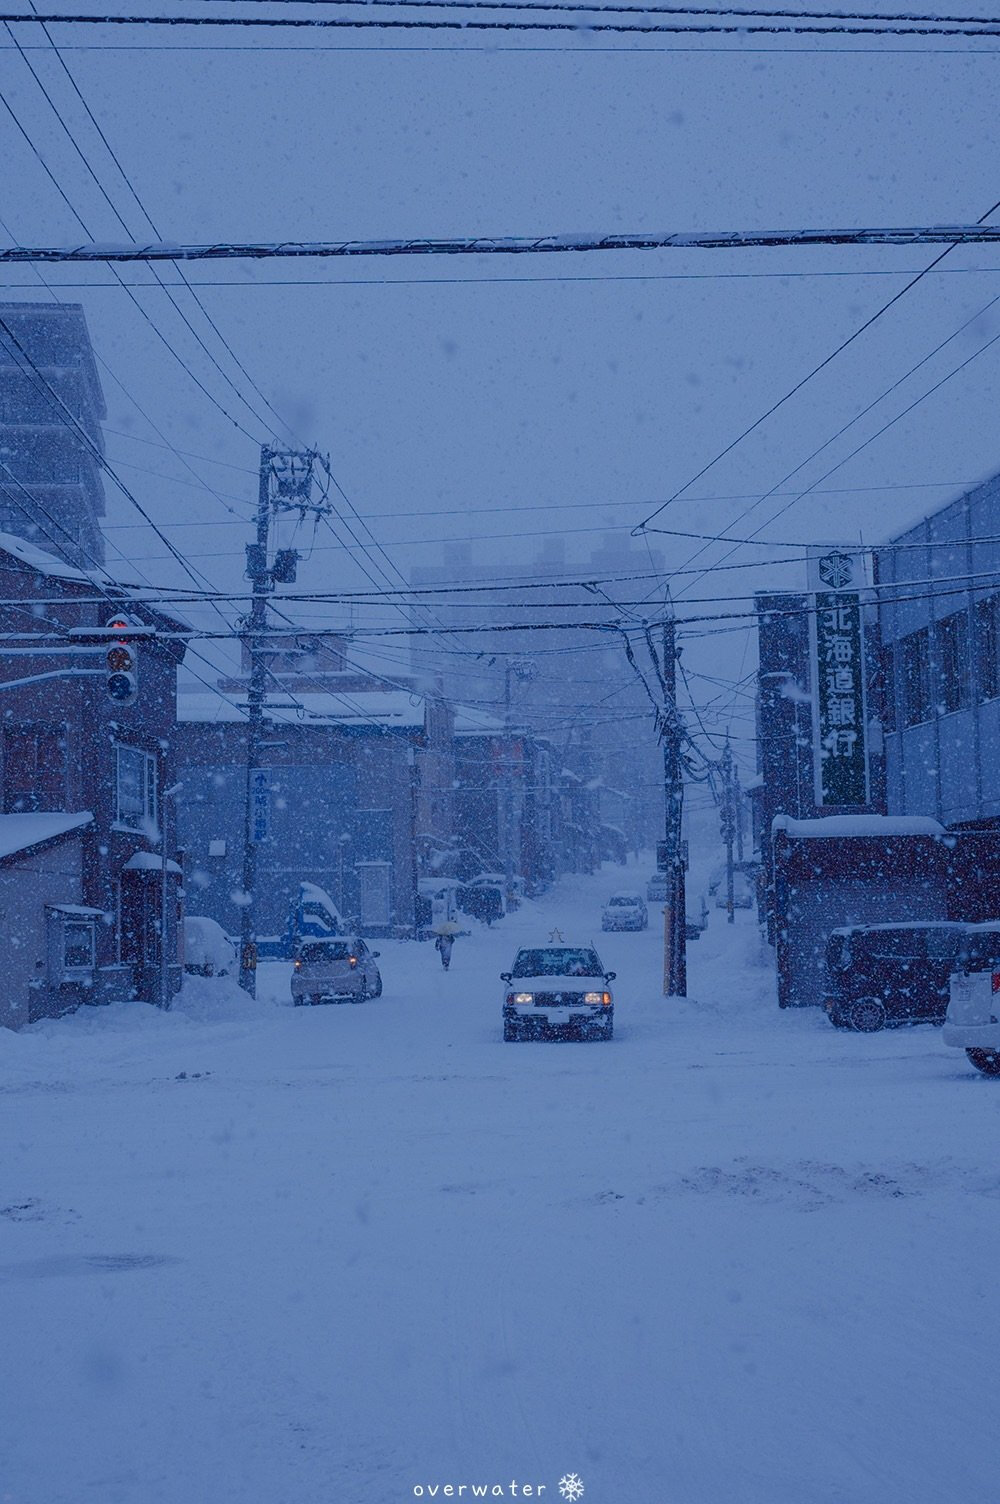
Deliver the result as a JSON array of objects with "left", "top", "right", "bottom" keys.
[{"left": 176, "top": 675, "right": 453, "bottom": 954}]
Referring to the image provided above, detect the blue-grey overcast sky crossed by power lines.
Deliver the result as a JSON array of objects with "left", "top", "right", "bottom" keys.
[{"left": 0, "top": 6, "right": 1000, "bottom": 767}]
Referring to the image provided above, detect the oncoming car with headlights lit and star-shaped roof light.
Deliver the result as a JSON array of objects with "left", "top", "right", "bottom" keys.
[{"left": 501, "top": 945, "right": 615, "bottom": 1041}]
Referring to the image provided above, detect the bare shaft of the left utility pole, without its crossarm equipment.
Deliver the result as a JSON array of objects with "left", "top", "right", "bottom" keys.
[{"left": 239, "top": 445, "right": 274, "bottom": 997}]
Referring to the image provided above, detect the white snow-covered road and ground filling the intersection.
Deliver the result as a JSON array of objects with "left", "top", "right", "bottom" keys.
[{"left": 0, "top": 866, "right": 1000, "bottom": 1504}]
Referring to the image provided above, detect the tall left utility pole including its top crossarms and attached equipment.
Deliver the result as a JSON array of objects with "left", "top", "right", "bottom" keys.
[{"left": 239, "top": 444, "right": 329, "bottom": 997}]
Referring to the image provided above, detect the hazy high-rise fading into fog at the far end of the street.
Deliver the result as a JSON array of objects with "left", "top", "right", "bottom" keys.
[{"left": 411, "top": 532, "right": 666, "bottom": 869}]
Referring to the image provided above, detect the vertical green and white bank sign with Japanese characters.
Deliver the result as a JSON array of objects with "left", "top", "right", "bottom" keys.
[{"left": 809, "top": 547, "right": 869, "bottom": 809}]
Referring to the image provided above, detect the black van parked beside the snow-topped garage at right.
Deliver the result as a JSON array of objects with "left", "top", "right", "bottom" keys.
[{"left": 823, "top": 920, "right": 968, "bottom": 1033}]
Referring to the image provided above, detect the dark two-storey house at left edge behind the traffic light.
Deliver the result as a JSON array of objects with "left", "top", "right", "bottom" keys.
[{"left": 0, "top": 534, "right": 186, "bottom": 1021}]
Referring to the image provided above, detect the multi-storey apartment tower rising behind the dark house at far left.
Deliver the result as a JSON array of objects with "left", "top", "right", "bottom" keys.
[{"left": 0, "top": 302, "right": 107, "bottom": 569}]
